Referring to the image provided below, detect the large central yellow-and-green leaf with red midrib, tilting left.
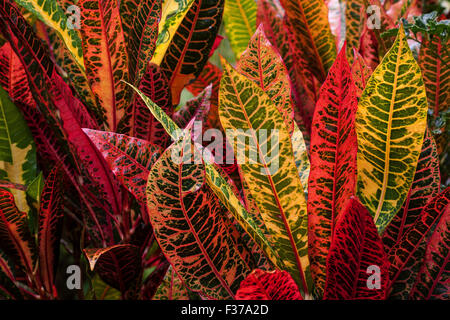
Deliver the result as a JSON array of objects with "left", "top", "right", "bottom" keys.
[{"left": 219, "top": 61, "right": 309, "bottom": 292}]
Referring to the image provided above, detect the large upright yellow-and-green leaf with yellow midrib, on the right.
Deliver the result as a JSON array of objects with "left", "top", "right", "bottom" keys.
[{"left": 356, "top": 26, "right": 428, "bottom": 233}]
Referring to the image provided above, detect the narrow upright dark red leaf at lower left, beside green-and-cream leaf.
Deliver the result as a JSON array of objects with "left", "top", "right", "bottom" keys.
[{"left": 38, "top": 165, "right": 64, "bottom": 293}]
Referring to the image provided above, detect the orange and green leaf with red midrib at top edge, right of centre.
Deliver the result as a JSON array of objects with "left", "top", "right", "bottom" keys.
[{"left": 280, "top": 0, "right": 336, "bottom": 82}]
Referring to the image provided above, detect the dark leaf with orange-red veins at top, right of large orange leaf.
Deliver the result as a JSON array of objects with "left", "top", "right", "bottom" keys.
[{"left": 120, "top": 0, "right": 162, "bottom": 84}]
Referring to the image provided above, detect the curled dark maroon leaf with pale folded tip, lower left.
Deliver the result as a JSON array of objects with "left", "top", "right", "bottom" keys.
[{"left": 83, "top": 244, "right": 142, "bottom": 298}]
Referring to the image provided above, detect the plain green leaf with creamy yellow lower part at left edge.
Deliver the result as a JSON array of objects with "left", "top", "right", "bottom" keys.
[{"left": 0, "top": 87, "right": 37, "bottom": 212}]
